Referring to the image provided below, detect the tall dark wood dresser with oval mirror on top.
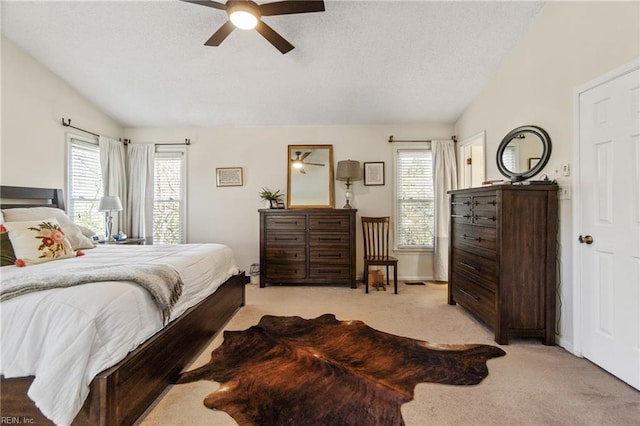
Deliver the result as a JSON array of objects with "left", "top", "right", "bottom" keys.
[{"left": 449, "top": 185, "right": 558, "bottom": 345}]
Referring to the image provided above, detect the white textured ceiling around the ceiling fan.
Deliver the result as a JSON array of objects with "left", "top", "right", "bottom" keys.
[{"left": 1, "top": 0, "right": 544, "bottom": 127}]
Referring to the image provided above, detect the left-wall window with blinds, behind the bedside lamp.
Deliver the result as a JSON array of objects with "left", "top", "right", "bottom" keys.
[{"left": 67, "top": 137, "right": 104, "bottom": 232}]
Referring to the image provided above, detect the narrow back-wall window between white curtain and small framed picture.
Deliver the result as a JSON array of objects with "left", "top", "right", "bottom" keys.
[{"left": 153, "top": 147, "right": 187, "bottom": 244}]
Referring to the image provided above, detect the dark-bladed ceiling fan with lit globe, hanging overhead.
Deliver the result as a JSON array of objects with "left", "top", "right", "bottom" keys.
[{"left": 183, "top": 0, "right": 324, "bottom": 55}]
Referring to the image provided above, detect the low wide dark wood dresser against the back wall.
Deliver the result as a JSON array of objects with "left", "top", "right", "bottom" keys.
[{"left": 259, "top": 209, "right": 357, "bottom": 288}]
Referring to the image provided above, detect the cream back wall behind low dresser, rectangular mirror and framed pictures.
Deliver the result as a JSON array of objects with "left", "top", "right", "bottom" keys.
[{"left": 125, "top": 124, "right": 453, "bottom": 279}]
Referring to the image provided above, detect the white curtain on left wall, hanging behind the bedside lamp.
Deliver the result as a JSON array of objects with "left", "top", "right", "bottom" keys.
[{"left": 98, "top": 136, "right": 129, "bottom": 234}]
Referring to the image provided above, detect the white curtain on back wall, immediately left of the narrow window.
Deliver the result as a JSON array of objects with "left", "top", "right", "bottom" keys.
[{"left": 127, "top": 144, "right": 155, "bottom": 243}]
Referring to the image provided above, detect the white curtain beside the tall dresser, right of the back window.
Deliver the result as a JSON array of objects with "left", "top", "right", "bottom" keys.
[{"left": 431, "top": 141, "right": 458, "bottom": 281}]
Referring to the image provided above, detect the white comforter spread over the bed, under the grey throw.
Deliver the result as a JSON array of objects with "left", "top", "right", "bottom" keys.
[{"left": 0, "top": 244, "right": 238, "bottom": 425}]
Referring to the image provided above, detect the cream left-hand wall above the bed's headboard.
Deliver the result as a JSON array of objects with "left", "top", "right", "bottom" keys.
[{"left": 0, "top": 37, "right": 123, "bottom": 189}]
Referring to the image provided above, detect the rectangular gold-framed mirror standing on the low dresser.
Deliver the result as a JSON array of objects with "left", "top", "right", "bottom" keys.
[{"left": 287, "top": 145, "right": 334, "bottom": 209}]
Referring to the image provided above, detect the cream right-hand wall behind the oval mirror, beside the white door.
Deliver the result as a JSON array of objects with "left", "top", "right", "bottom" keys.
[{"left": 456, "top": 2, "right": 640, "bottom": 350}]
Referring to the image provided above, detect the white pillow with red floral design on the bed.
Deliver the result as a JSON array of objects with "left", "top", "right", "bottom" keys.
[{"left": 4, "top": 217, "right": 76, "bottom": 265}]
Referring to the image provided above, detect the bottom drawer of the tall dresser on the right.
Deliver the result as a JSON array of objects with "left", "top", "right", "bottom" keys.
[{"left": 451, "top": 273, "right": 496, "bottom": 327}]
